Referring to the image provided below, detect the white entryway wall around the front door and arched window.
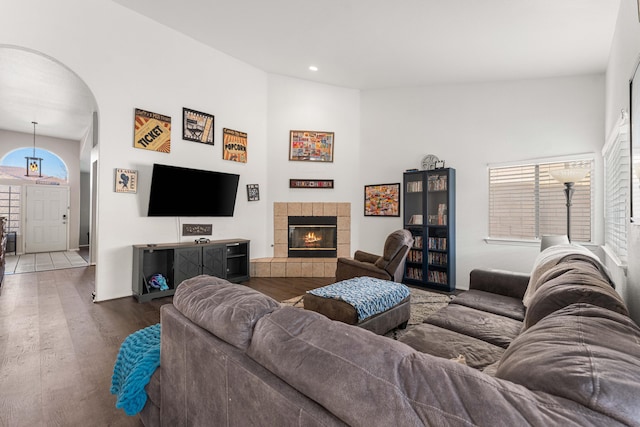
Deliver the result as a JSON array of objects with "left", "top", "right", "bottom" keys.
[{"left": 0, "top": 129, "right": 80, "bottom": 253}]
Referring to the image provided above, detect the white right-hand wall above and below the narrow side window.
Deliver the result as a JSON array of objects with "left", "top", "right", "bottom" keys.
[{"left": 605, "top": 0, "right": 640, "bottom": 322}]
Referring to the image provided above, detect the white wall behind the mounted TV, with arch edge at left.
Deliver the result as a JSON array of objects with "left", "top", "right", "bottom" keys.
[{"left": 0, "top": 0, "right": 267, "bottom": 301}]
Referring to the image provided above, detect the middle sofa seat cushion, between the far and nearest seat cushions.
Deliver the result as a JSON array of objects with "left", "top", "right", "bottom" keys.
[{"left": 424, "top": 304, "right": 522, "bottom": 348}]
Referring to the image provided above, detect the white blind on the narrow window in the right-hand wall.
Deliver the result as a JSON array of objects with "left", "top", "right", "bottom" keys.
[{"left": 602, "top": 114, "right": 631, "bottom": 264}]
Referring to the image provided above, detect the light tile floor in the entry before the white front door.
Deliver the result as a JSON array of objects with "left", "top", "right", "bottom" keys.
[{"left": 4, "top": 251, "right": 89, "bottom": 274}]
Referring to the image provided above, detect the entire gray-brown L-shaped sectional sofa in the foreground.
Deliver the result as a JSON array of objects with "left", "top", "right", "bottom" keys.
[{"left": 140, "top": 246, "right": 640, "bottom": 427}]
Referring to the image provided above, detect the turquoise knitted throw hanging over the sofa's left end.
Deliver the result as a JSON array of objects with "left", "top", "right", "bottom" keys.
[{"left": 111, "top": 323, "right": 160, "bottom": 415}]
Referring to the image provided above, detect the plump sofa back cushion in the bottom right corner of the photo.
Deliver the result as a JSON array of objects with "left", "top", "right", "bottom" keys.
[{"left": 496, "top": 304, "right": 640, "bottom": 425}]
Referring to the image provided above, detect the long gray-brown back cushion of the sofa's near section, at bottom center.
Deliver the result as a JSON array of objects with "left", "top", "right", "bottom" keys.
[{"left": 246, "top": 307, "right": 616, "bottom": 426}]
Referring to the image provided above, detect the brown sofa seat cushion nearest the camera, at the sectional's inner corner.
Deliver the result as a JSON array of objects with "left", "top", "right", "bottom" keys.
[{"left": 398, "top": 323, "right": 504, "bottom": 369}]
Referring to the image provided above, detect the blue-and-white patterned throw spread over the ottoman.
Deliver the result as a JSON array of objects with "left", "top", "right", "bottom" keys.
[{"left": 307, "top": 277, "right": 410, "bottom": 322}]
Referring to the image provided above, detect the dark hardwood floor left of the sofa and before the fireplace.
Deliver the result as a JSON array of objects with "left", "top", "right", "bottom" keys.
[{"left": 0, "top": 267, "right": 334, "bottom": 426}]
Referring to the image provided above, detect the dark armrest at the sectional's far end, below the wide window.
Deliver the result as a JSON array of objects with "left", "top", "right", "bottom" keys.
[{"left": 469, "top": 268, "right": 530, "bottom": 299}]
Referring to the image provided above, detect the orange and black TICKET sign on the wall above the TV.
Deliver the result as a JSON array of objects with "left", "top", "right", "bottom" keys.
[{"left": 133, "top": 108, "right": 171, "bottom": 153}]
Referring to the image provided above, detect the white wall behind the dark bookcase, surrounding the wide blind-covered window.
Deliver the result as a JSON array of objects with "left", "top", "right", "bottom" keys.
[{"left": 359, "top": 75, "right": 604, "bottom": 289}]
